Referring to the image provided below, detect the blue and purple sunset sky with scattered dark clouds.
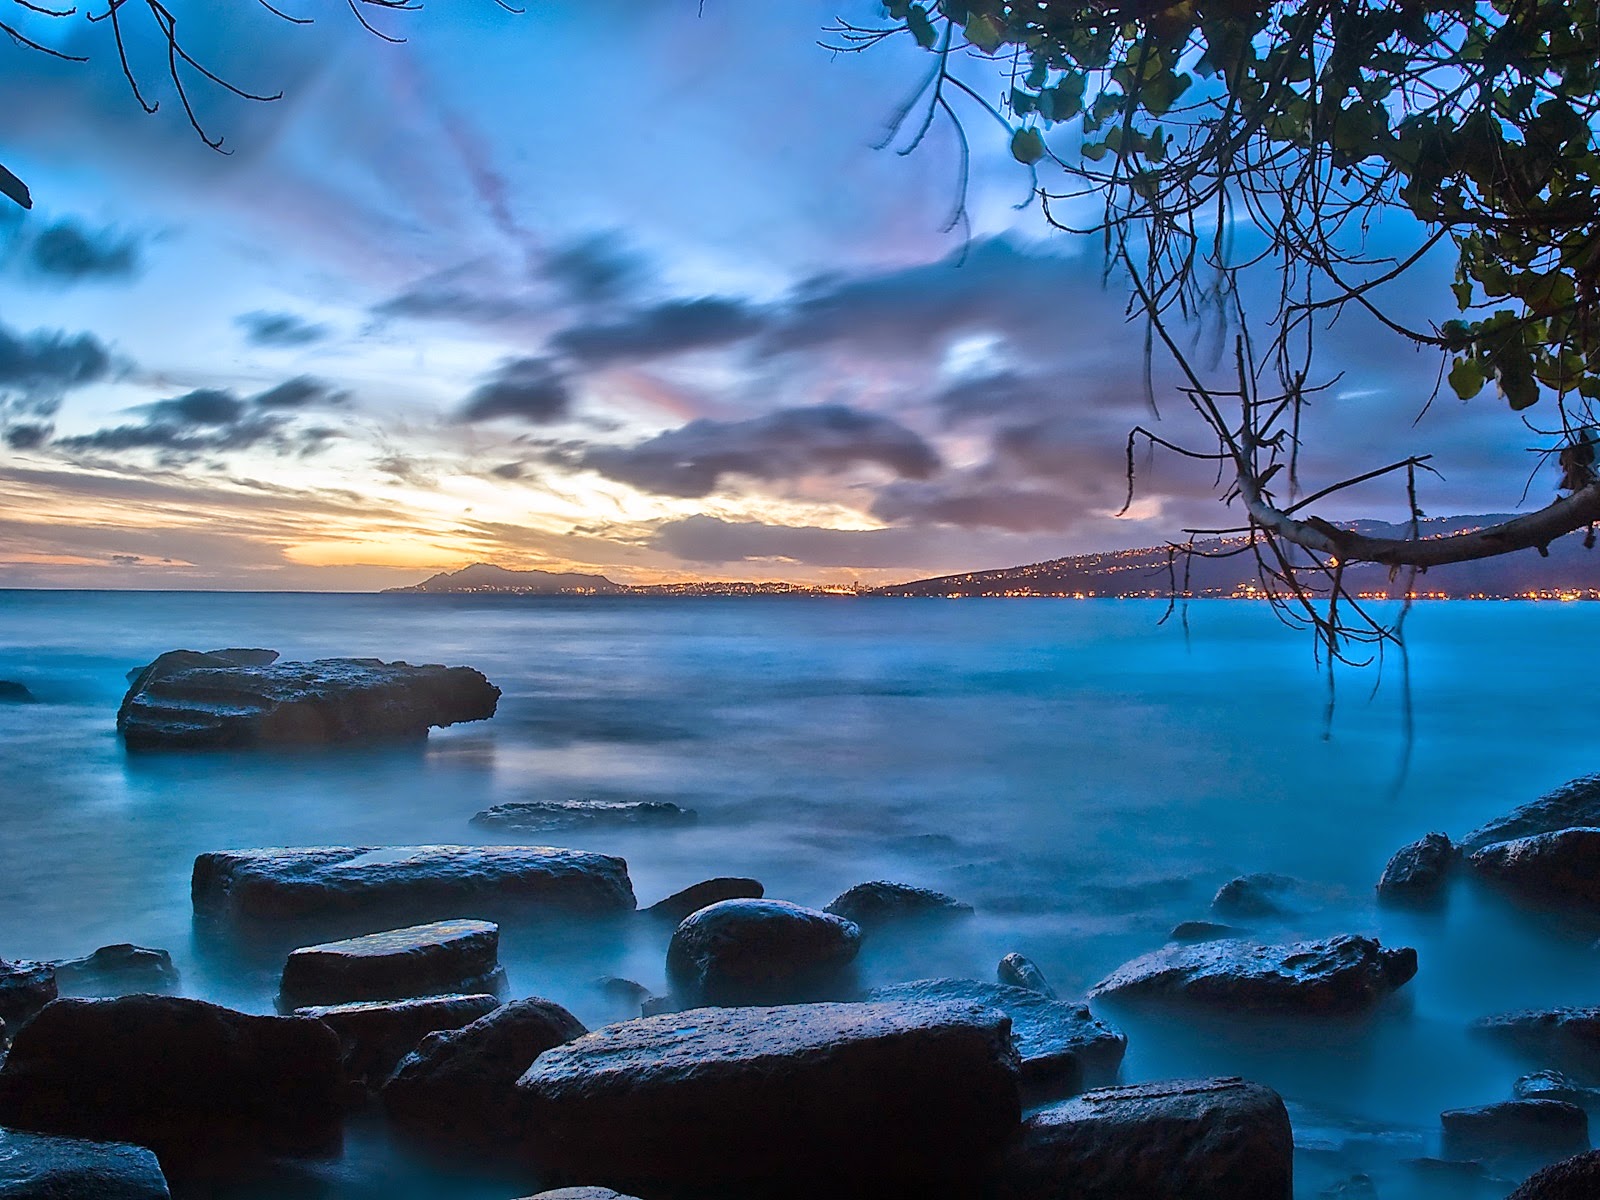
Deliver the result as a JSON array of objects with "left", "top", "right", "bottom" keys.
[{"left": 0, "top": 0, "right": 1554, "bottom": 590}]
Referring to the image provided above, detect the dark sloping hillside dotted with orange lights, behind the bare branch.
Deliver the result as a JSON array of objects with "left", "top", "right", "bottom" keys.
[{"left": 872, "top": 514, "right": 1600, "bottom": 600}]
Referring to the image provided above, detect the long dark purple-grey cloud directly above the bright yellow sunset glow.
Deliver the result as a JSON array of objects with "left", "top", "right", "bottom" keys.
[{"left": 578, "top": 405, "right": 939, "bottom": 498}]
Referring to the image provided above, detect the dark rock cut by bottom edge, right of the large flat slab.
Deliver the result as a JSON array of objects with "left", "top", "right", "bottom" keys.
[{"left": 995, "top": 1078, "right": 1294, "bottom": 1200}]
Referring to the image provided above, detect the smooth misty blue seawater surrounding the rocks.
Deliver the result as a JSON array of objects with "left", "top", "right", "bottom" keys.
[{"left": 0, "top": 592, "right": 1600, "bottom": 1200}]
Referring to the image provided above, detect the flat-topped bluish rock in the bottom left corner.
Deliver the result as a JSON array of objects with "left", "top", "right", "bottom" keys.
[{"left": 0, "top": 1130, "right": 171, "bottom": 1200}]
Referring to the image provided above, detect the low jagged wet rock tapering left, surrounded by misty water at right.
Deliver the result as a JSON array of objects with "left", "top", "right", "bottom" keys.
[{"left": 1090, "top": 934, "right": 1416, "bottom": 1013}]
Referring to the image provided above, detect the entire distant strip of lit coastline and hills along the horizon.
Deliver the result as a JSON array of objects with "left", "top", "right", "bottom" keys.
[{"left": 386, "top": 514, "right": 1600, "bottom": 600}]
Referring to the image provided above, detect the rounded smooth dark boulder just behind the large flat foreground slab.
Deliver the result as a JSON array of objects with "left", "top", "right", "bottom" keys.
[{"left": 667, "top": 899, "right": 861, "bottom": 1006}]
